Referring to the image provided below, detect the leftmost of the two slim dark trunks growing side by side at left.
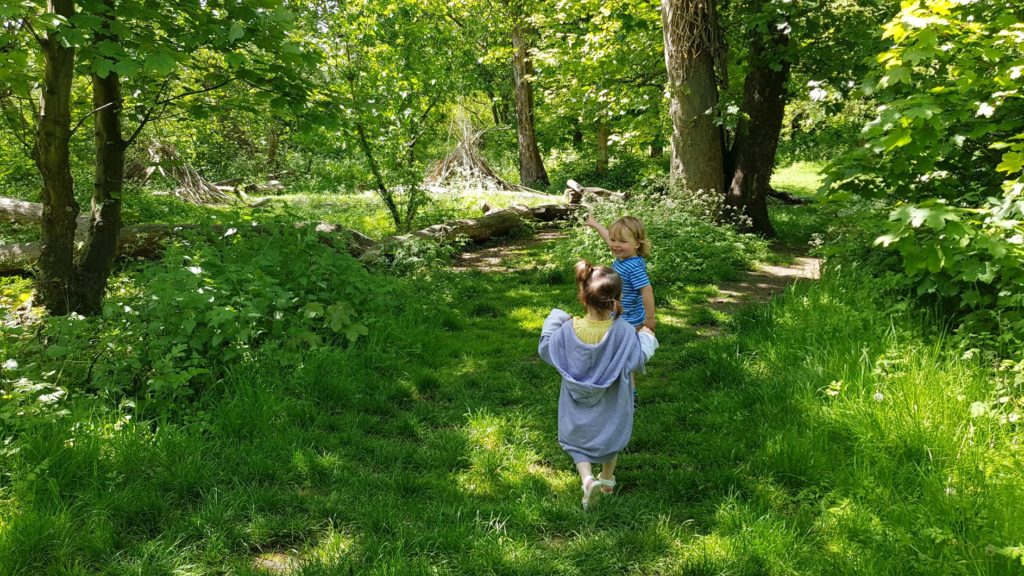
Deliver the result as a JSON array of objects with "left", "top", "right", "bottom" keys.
[{"left": 33, "top": 0, "right": 79, "bottom": 316}]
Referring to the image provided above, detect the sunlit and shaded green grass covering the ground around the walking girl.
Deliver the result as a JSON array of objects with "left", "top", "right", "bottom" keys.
[{"left": 0, "top": 186, "right": 1024, "bottom": 576}]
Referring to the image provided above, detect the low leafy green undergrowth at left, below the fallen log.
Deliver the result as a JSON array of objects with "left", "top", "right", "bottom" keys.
[{"left": 2, "top": 220, "right": 375, "bottom": 410}]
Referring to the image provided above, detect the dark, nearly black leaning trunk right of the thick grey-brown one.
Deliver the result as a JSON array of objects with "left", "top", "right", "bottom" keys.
[{"left": 725, "top": 6, "right": 790, "bottom": 237}]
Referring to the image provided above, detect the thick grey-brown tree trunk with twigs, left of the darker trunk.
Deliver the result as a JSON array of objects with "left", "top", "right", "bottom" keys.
[{"left": 662, "top": 0, "right": 725, "bottom": 199}]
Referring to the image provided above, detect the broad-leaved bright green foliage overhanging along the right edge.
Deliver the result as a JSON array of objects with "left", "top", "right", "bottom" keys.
[{"left": 827, "top": 0, "right": 1024, "bottom": 354}]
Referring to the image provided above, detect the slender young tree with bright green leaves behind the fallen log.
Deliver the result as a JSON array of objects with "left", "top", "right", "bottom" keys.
[{"left": 296, "top": 1, "right": 472, "bottom": 231}]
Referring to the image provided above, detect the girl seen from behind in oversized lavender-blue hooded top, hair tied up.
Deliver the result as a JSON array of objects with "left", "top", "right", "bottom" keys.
[{"left": 538, "top": 260, "right": 658, "bottom": 509}]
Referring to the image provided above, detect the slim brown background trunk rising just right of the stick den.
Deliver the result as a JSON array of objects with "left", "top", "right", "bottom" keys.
[{"left": 512, "top": 23, "right": 548, "bottom": 189}]
